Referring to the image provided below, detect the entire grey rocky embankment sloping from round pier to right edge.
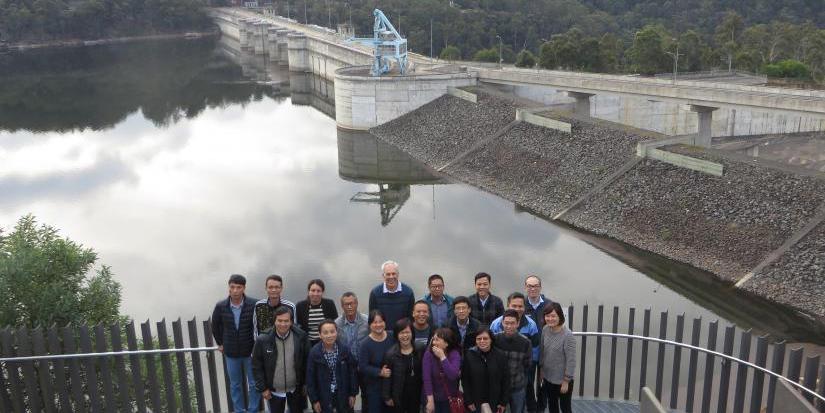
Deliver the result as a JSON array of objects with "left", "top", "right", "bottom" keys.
[{"left": 372, "top": 91, "right": 825, "bottom": 320}]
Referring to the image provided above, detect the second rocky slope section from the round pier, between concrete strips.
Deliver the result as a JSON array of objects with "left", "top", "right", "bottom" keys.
[{"left": 445, "top": 116, "right": 648, "bottom": 216}]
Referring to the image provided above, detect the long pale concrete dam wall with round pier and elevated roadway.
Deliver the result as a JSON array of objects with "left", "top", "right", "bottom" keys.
[{"left": 210, "top": 8, "right": 825, "bottom": 134}]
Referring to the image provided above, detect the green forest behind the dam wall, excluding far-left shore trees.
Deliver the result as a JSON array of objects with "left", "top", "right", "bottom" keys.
[{"left": 271, "top": 0, "right": 825, "bottom": 80}]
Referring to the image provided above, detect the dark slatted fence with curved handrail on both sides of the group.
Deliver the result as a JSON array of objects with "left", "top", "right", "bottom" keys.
[{"left": 0, "top": 305, "right": 825, "bottom": 413}]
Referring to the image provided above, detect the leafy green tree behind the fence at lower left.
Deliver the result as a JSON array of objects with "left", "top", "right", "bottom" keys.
[{"left": 0, "top": 215, "right": 122, "bottom": 327}]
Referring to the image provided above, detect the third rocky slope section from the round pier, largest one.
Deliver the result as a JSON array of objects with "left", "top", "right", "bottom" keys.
[{"left": 562, "top": 147, "right": 825, "bottom": 281}]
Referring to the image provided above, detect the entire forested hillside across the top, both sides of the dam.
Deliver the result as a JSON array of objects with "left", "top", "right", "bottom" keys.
[{"left": 0, "top": 0, "right": 825, "bottom": 81}]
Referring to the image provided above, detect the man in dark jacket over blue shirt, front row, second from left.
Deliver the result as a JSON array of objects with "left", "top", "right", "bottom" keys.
[{"left": 306, "top": 320, "right": 358, "bottom": 413}]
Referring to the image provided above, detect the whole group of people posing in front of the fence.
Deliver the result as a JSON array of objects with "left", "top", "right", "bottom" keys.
[{"left": 211, "top": 261, "right": 576, "bottom": 413}]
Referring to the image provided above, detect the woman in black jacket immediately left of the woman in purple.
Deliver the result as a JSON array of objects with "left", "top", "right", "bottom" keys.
[{"left": 381, "top": 318, "right": 427, "bottom": 413}]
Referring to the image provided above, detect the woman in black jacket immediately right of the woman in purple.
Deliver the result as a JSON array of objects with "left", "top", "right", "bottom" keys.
[{"left": 461, "top": 327, "right": 510, "bottom": 413}]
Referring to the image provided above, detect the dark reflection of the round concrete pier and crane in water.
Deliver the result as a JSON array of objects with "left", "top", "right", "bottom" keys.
[{"left": 338, "top": 128, "right": 449, "bottom": 226}]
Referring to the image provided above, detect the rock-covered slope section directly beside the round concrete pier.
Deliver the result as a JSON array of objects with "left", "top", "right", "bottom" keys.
[{"left": 370, "top": 92, "right": 517, "bottom": 168}]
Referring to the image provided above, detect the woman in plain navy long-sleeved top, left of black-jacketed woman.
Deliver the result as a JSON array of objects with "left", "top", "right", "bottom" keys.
[{"left": 358, "top": 310, "right": 393, "bottom": 413}]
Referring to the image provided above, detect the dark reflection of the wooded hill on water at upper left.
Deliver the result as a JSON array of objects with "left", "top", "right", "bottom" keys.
[{"left": 0, "top": 39, "right": 279, "bottom": 132}]
